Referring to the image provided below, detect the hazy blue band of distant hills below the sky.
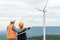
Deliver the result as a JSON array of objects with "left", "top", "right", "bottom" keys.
[{"left": 0, "top": 27, "right": 60, "bottom": 35}]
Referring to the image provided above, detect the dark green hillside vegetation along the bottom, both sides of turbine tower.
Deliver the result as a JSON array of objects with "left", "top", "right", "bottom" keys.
[{"left": 28, "top": 34, "right": 60, "bottom": 40}]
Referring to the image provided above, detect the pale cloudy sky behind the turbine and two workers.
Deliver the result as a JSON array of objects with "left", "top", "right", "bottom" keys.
[{"left": 0, "top": 0, "right": 60, "bottom": 30}]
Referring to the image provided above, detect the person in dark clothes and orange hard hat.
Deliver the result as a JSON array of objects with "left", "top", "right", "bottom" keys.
[{"left": 17, "top": 22, "right": 30, "bottom": 40}]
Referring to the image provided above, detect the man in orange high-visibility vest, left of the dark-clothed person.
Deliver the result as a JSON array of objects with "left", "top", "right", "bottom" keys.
[{"left": 7, "top": 21, "right": 16, "bottom": 40}]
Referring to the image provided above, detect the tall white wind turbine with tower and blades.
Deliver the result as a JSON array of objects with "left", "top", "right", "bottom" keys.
[{"left": 36, "top": 0, "right": 48, "bottom": 40}]
